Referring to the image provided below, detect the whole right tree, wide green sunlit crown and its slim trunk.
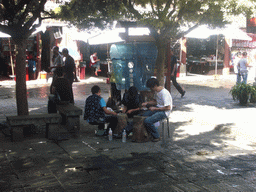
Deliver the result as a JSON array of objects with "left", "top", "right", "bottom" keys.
[{"left": 57, "top": 0, "right": 255, "bottom": 83}]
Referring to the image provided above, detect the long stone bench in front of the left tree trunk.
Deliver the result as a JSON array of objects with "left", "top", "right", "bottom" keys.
[{"left": 6, "top": 113, "right": 61, "bottom": 141}]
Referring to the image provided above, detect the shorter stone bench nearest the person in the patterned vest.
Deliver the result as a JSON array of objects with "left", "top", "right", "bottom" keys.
[{"left": 57, "top": 103, "right": 83, "bottom": 135}]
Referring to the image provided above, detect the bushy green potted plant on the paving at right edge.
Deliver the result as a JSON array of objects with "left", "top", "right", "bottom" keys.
[{"left": 230, "top": 83, "right": 256, "bottom": 105}]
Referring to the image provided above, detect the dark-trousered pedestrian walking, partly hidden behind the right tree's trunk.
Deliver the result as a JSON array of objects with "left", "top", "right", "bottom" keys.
[{"left": 170, "top": 49, "right": 186, "bottom": 97}]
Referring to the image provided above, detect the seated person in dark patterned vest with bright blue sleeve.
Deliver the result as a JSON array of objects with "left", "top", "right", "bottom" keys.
[{"left": 84, "top": 85, "right": 117, "bottom": 135}]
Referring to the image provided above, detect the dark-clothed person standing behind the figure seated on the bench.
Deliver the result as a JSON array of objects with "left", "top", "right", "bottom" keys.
[{"left": 62, "top": 48, "right": 76, "bottom": 104}]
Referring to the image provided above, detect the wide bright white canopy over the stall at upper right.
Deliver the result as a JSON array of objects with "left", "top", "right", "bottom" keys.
[{"left": 185, "top": 25, "right": 252, "bottom": 41}]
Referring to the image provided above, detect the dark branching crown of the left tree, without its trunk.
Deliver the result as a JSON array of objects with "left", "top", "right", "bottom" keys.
[{"left": 0, "top": 0, "right": 52, "bottom": 39}]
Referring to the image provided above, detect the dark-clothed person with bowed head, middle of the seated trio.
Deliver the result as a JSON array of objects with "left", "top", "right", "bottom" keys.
[{"left": 122, "top": 86, "right": 143, "bottom": 118}]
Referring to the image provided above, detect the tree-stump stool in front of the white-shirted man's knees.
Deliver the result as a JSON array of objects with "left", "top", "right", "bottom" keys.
[{"left": 132, "top": 115, "right": 150, "bottom": 143}]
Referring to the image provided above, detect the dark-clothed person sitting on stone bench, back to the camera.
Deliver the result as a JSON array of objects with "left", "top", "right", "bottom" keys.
[{"left": 48, "top": 67, "right": 73, "bottom": 113}]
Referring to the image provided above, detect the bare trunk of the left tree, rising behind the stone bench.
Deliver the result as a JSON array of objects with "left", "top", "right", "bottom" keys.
[{"left": 14, "top": 39, "right": 29, "bottom": 116}]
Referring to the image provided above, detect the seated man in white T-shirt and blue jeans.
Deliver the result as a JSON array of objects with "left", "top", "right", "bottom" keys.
[{"left": 142, "top": 78, "right": 172, "bottom": 142}]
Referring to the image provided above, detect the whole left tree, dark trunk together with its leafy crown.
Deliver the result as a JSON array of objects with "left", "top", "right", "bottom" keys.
[{"left": 0, "top": 0, "right": 51, "bottom": 115}]
